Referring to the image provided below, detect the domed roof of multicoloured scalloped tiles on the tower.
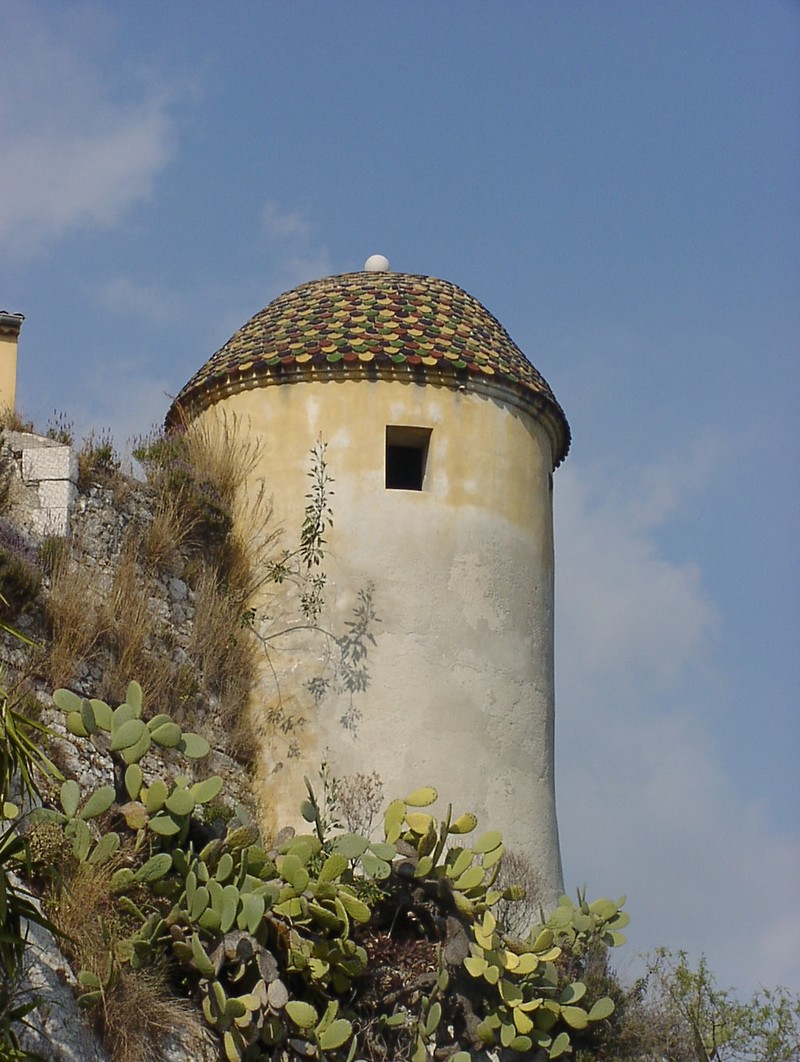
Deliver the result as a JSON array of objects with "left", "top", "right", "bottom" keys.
[{"left": 167, "top": 272, "right": 569, "bottom": 465}]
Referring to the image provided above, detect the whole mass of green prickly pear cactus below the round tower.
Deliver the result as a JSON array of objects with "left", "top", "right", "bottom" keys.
[{"left": 38, "top": 683, "right": 626, "bottom": 1062}]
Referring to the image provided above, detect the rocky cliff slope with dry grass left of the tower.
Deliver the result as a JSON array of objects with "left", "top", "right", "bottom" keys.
[{"left": 0, "top": 433, "right": 256, "bottom": 1062}]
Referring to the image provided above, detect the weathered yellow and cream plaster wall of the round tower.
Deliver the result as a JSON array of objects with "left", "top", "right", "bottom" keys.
[{"left": 202, "top": 380, "right": 562, "bottom": 896}]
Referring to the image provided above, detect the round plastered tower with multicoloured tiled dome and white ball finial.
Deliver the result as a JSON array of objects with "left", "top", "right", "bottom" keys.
[{"left": 167, "top": 263, "right": 569, "bottom": 900}]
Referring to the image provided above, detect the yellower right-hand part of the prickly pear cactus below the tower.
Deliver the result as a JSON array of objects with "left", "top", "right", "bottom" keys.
[{"left": 365, "top": 788, "right": 627, "bottom": 1062}]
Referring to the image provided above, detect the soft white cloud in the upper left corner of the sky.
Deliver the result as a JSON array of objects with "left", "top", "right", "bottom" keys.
[{"left": 0, "top": 5, "right": 172, "bottom": 255}]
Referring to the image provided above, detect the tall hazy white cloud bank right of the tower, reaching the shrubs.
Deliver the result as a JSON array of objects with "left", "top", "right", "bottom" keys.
[{"left": 556, "top": 458, "right": 800, "bottom": 991}]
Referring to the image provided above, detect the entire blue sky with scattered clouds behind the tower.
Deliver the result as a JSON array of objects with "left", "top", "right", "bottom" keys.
[{"left": 0, "top": 0, "right": 800, "bottom": 989}]
